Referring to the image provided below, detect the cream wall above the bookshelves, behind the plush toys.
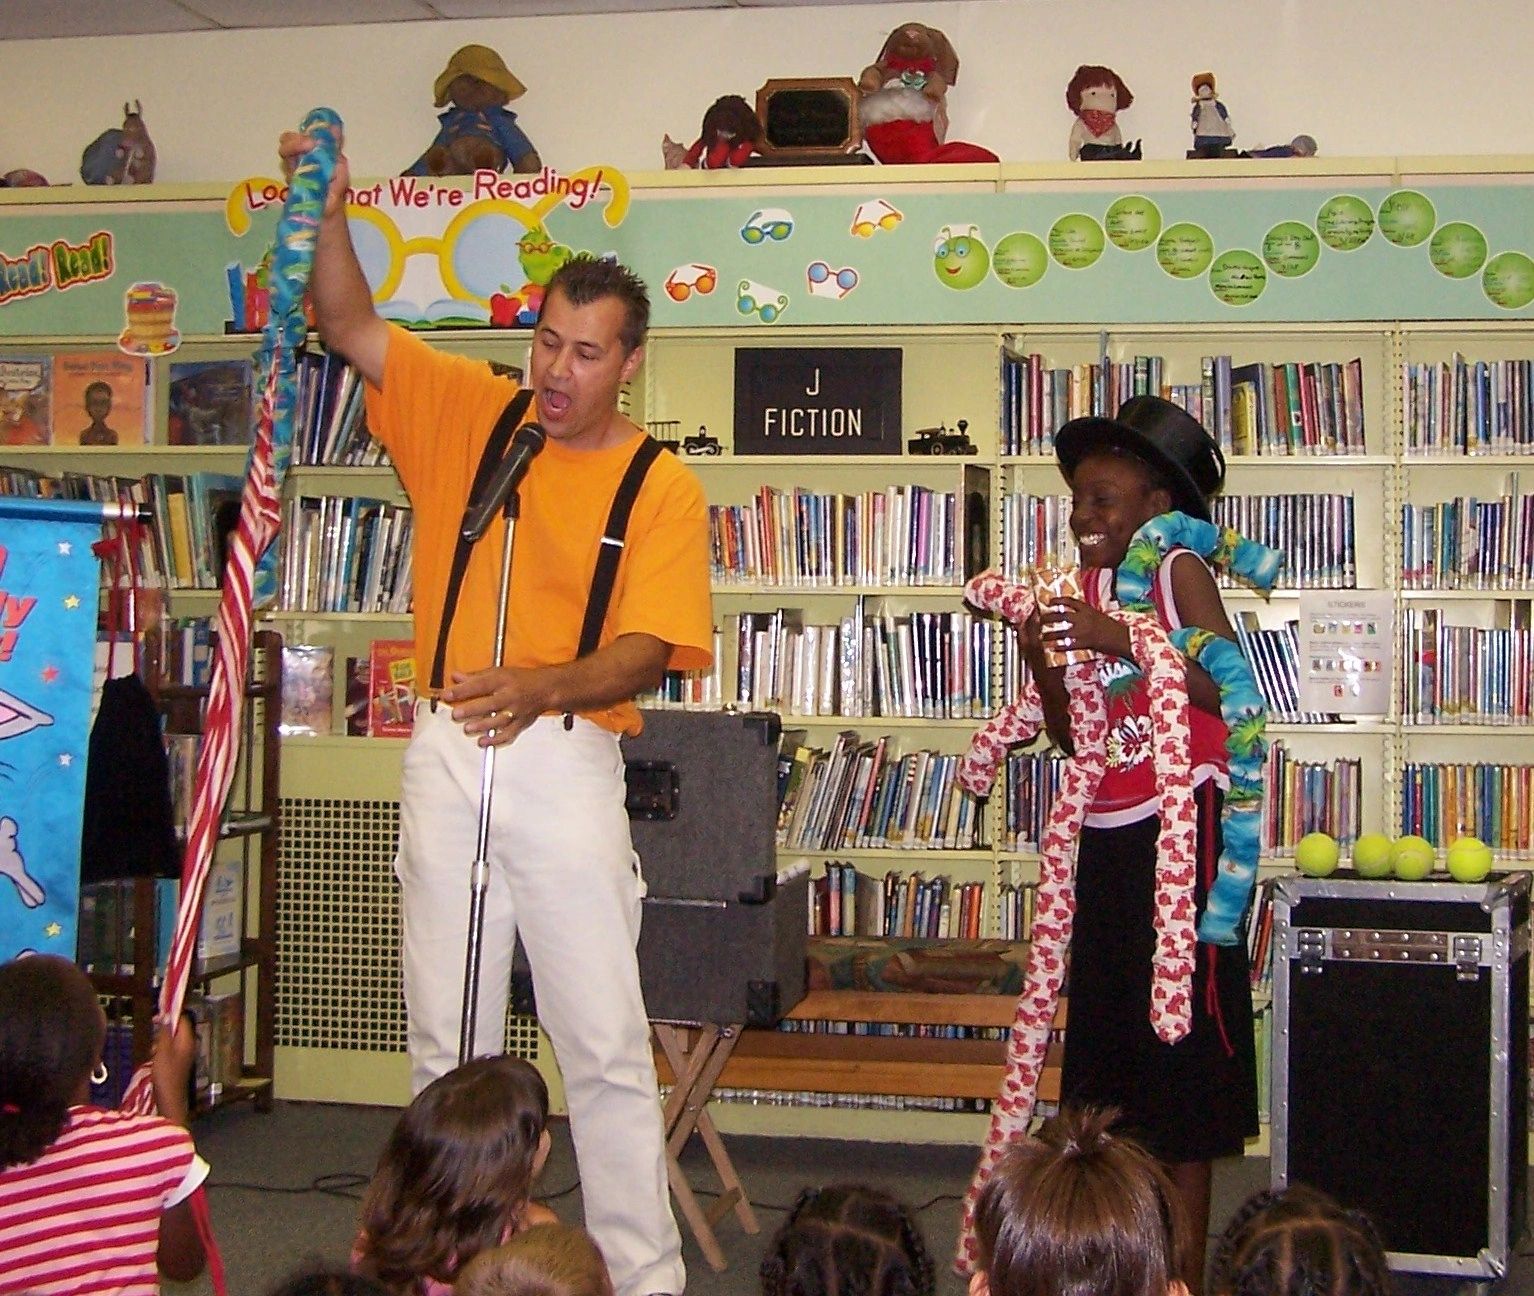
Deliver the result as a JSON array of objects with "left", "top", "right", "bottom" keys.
[{"left": 0, "top": 0, "right": 1534, "bottom": 183}]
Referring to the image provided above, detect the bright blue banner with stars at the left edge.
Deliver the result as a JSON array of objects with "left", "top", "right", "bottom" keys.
[{"left": 0, "top": 498, "right": 101, "bottom": 959}]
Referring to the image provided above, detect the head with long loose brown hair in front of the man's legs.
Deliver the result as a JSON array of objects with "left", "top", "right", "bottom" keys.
[{"left": 357, "top": 1057, "right": 549, "bottom": 1290}]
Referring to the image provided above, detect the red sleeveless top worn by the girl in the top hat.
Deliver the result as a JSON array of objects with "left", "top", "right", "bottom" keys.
[{"left": 1083, "top": 549, "right": 1230, "bottom": 828}]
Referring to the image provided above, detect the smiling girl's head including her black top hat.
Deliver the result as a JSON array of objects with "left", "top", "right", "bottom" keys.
[{"left": 1055, "top": 396, "right": 1226, "bottom": 567}]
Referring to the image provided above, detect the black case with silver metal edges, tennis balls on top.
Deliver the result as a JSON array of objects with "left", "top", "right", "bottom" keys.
[{"left": 1272, "top": 871, "right": 1529, "bottom": 1279}]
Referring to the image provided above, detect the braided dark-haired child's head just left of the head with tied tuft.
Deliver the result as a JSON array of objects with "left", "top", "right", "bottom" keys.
[{"left": 761, "top": 1184, "right": 936, "bottom": 1296}]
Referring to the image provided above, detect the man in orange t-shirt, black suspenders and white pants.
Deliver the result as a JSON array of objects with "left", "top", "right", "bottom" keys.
[{"left": 281, "top": 135, "right": 712, "bottom": 1296}]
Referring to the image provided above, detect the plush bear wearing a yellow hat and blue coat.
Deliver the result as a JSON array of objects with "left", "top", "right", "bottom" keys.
[{"left": 405, "top": 44, "right": 543, "bottom": 175}]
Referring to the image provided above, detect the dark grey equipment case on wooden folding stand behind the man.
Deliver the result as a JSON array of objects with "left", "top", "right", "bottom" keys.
[{"left": 623, "top": 710, "right": 808, "bottom": 1026}]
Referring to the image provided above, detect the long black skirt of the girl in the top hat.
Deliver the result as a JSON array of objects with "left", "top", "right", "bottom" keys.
[{"left": 1062, "top": 781, "right": 1258, "bottom": 1163}]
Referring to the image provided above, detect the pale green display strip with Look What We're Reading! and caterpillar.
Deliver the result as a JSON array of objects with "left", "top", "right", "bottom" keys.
[{"left": 0, "top": 164, "right": 1534, "bottom": 343}]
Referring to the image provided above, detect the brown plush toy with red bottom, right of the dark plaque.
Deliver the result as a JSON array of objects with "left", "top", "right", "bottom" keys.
[{"left": 858, "top": 23, "right": 999, "bottom": 163}]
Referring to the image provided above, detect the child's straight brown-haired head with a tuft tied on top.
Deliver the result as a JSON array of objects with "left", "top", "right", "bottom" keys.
[{"left": 969, "top": 1109, "right": 1184, "bottom": 1296}]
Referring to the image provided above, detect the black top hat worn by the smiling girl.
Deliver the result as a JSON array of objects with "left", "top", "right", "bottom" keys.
[{"left": 1055, "top": 396, "right": 1226, "bottom": 521}]
